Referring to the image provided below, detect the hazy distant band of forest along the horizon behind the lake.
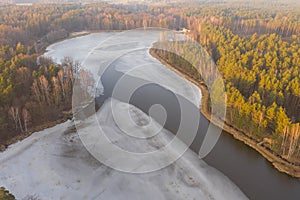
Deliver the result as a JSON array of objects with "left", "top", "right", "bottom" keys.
[{"left": 0, "top": 3, "right": 300, "bottom": 46}]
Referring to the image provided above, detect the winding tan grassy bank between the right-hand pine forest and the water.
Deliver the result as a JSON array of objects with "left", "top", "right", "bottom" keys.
[{"left": 149, "top": 49, "right": 300, "bottom": 178}]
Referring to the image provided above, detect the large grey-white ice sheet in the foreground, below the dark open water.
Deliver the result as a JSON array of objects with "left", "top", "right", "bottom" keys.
[{"left": 0, "top": 99, "right": 246, "bottom": 200}]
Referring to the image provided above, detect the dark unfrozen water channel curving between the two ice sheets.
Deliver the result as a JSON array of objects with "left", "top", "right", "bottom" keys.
[{"left": 96, "top": 54, "right": 300, "bottom": 200}]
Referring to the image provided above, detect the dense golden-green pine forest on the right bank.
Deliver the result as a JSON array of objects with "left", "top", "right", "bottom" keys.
[{"left": 151, "top": 2, "right": 300, "bottom": 165}]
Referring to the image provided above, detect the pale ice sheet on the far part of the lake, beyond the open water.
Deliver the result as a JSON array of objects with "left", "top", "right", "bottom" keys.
[{"left": 44, "top": 31, "right": 201, "bottom": 107}]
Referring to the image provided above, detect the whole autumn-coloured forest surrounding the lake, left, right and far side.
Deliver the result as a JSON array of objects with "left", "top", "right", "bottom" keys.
[{"left": 0, "top": 2, "right": 300, "bottom": 165}]
